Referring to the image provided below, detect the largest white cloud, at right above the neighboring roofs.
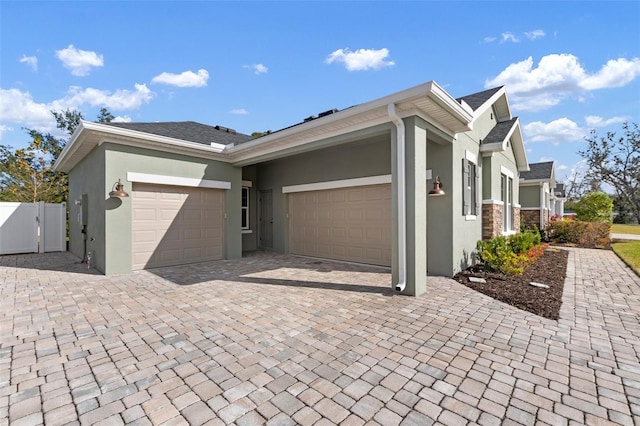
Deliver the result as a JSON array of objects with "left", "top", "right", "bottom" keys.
[{"left": 485, "top": 53, "right": 640, "bottom": 111}]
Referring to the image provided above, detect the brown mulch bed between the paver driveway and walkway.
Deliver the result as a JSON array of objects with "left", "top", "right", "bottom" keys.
[{"left": 453, "top": 248, "right": 569, "bottom": 320}]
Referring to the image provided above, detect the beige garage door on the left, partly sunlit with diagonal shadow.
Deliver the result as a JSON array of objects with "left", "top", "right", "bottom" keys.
[{"left": 131, "top": 183, "right": 224, "bottom": 270}]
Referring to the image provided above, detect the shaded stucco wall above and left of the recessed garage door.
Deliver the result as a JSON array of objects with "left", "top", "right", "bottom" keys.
[{"left": 257, "top": 131, "right": 391, "bottom": 253}]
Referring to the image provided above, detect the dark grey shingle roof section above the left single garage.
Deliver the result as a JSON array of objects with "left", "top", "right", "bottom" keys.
[{"left": 105, "top": 121, "right": 253, "bottom": 145}]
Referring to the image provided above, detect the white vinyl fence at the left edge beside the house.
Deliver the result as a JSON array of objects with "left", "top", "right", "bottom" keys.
[{"left": 0, "top": 201, "right": 67, "bottom": 254}]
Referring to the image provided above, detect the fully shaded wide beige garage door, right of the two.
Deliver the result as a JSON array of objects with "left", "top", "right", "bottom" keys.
[{"left": 289, "top": 185, "right": 391, "bottom": 266}]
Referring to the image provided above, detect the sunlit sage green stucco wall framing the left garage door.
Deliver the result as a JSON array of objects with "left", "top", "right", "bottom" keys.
[{"left": 103, "top": 143, "right": 242, "bottom": 274}]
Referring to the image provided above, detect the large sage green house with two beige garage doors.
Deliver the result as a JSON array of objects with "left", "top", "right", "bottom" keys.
[{"left": 55, "top": 82, "right": 528, "bottom": 295}]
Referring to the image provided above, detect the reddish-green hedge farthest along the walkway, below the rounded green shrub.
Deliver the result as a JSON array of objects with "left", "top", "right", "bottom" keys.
[{"left": 546, "top": 219, "right": 611, "bottom": 247}]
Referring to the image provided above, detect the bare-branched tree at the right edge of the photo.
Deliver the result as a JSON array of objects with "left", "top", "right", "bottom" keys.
[{"left": 578, "top": 122, "right": 640, "bottom": 219}]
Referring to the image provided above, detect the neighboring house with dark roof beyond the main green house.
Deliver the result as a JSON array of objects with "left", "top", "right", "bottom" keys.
[{"left": 520, "top": 161, "right": 565, "bottom": 229}]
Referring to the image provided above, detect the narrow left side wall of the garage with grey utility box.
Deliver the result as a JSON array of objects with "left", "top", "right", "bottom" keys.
[{"left": 69, "top": 145, "right": 105, "bottom": 272}]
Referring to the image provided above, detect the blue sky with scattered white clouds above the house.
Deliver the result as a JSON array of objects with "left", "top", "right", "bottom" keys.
[{"left": 0, "top": 0, "right": 640, "bottom": 180}]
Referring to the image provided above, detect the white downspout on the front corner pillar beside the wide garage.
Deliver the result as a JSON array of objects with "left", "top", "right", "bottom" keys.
[{"left": 387, "top": 103, "right": 407, "bottom": 292}]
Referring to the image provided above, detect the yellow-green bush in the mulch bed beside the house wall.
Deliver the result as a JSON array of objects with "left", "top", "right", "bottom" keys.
[{"left": 477, "top": 231, "right": 544, "bottom": 275}]
